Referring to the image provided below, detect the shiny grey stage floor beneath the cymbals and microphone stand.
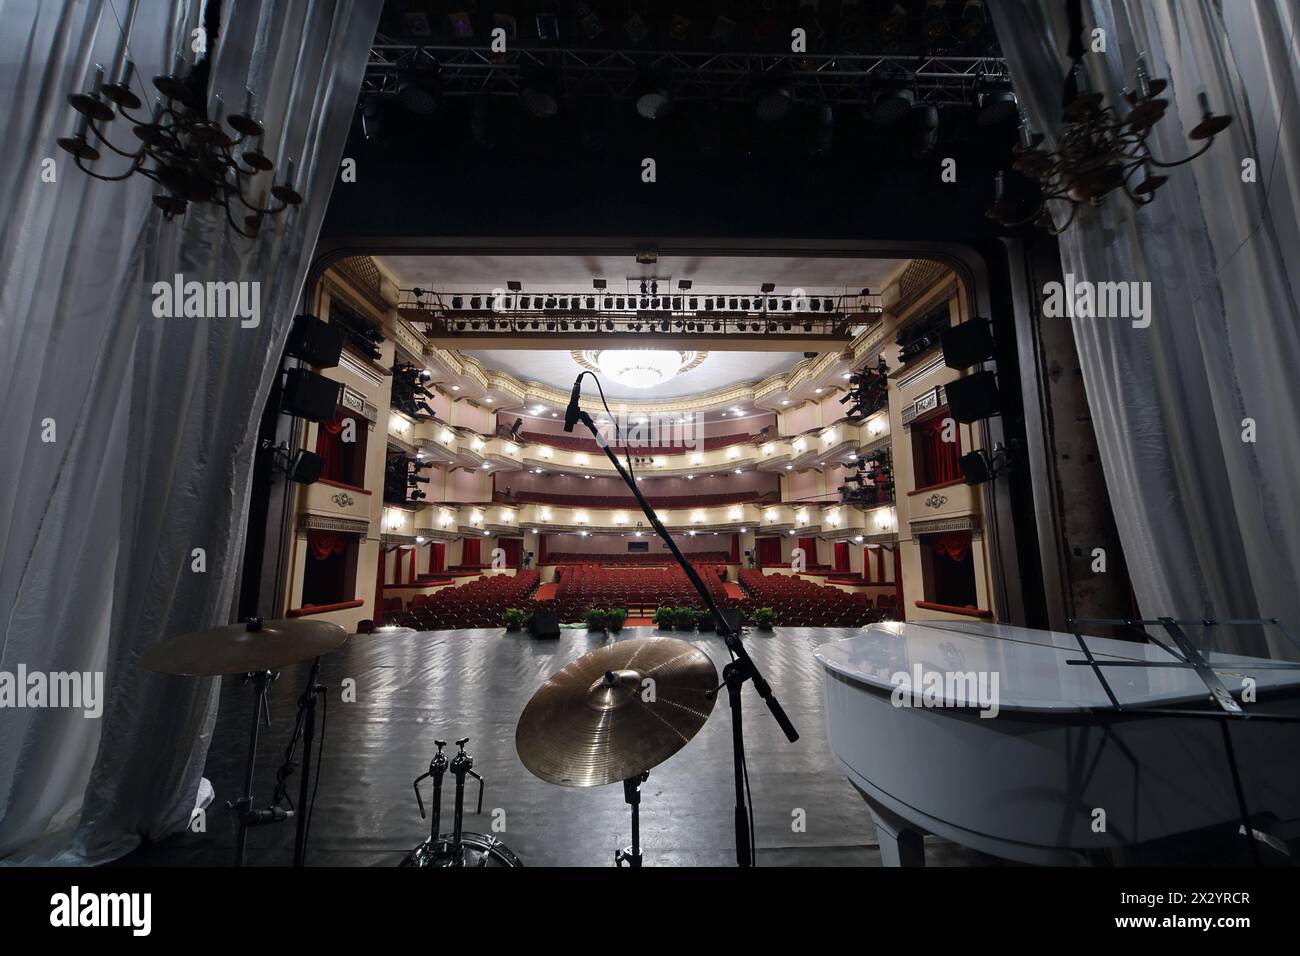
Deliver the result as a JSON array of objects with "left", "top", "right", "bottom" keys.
[{"left": 121, "top": 627, "right": 989, "bottom": 866}]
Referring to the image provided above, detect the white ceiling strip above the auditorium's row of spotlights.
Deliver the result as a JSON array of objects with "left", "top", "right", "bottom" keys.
[{"left": 377, "top": 255, "right": 906, "bottom": 295}]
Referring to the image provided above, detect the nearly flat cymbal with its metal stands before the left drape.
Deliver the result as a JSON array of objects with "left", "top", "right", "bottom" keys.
[{"left": 140, "top": 618, "right": 347, "bottom": 866}]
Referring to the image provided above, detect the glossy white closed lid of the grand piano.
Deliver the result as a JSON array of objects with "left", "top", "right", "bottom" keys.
[{"left": 816, "top": 620, "right": 1300, "bottom": 713}]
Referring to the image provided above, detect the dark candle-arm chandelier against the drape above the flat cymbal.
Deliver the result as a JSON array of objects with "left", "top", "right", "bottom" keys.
[{"left": 59, "top": 0, "right": 303, "bottom": 238}]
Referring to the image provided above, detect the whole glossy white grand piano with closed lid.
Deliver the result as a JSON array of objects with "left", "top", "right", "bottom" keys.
[{"left": 816, "top": 622, "right": 1300, "bottom": 866}]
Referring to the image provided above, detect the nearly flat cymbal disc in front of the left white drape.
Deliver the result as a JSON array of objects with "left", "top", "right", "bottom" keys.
[{"left": 140, "top": 619, "right": 347, "bottom": 678}]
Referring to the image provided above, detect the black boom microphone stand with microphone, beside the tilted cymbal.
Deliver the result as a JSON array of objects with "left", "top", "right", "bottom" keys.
[{"left": 564, "top": 403, "right": 800, "bottom": 866}]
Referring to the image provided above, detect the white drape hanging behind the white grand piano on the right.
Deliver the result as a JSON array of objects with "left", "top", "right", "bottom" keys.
[{"left": 989, "top": 0, "right": 1300, "bottom": 656}]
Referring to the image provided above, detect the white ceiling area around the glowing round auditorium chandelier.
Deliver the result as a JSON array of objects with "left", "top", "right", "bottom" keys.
[{"left": 463, "top": 349, "right": 803, "bottom": 401}]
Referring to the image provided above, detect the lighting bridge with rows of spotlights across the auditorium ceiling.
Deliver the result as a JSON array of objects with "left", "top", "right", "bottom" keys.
[{"left": 394, "top": 287, "right": 884, "bottom": 340}]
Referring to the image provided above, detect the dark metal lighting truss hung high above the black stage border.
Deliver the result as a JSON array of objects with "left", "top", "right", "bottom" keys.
[{"left": 361, "top": 43, "right": 1010, "bottom": 107}]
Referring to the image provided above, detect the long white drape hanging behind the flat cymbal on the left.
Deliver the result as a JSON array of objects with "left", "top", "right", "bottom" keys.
[{"left": 0, "top": 0, "right": 381, "bottom": 862}]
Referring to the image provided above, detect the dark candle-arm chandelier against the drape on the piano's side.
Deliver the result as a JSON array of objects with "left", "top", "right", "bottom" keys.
[{"left": 985, "top": 56, "right": 1232, "bottom": 235}]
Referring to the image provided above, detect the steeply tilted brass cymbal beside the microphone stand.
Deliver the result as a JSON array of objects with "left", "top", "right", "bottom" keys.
[{"left": 515, "top": 637, "right": 718, "bottom": 787}]
